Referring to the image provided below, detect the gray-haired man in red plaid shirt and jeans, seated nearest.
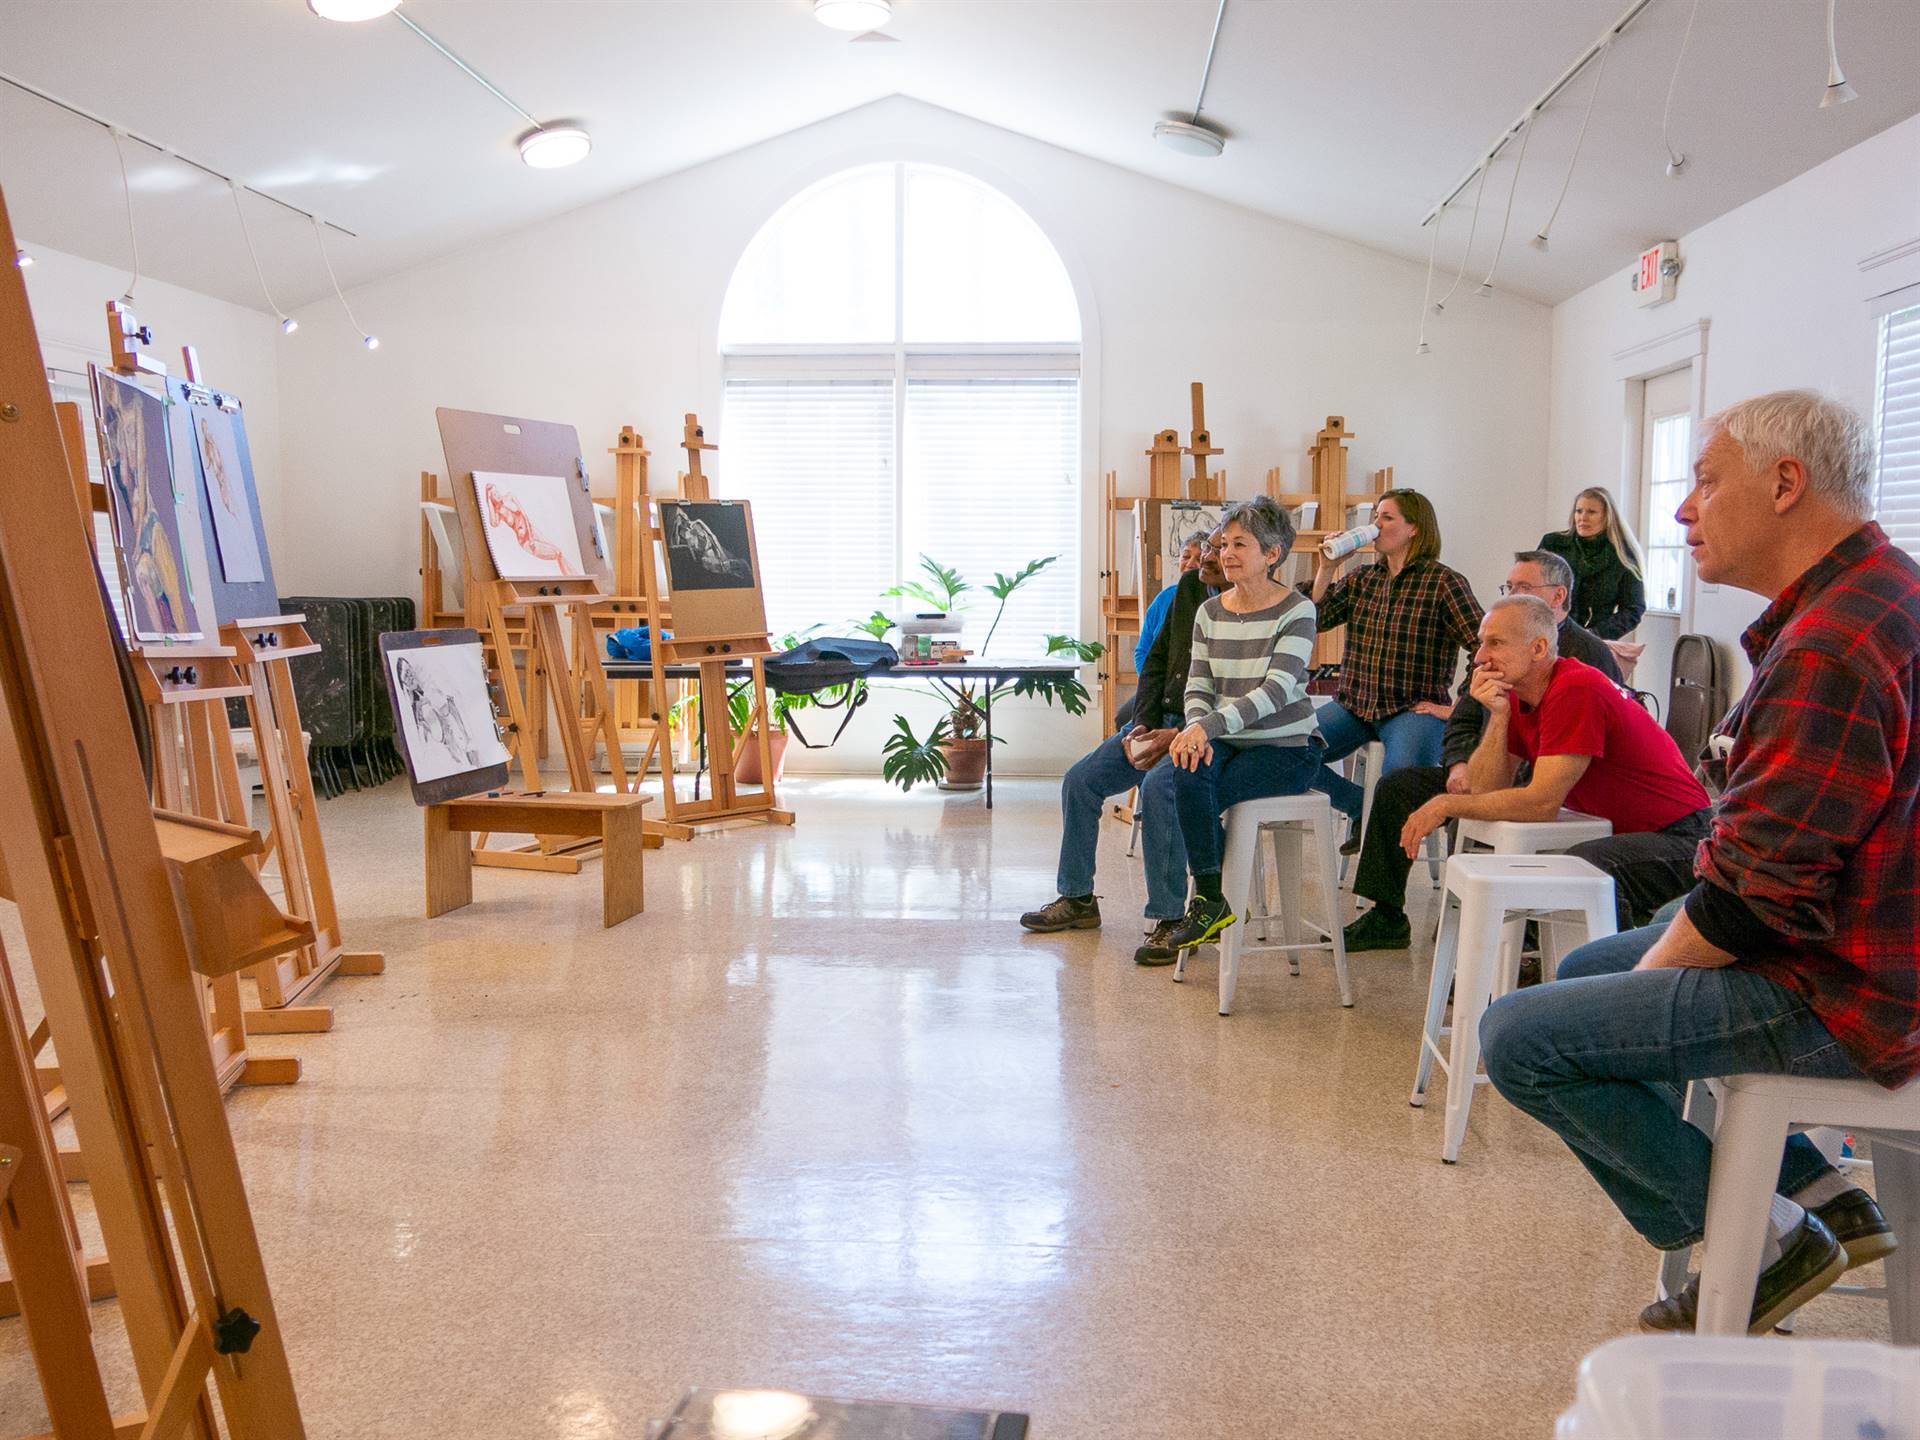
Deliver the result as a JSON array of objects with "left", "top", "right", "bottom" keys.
[{"left": 1480, "top": 392, "right": 1920, "bottom": 1332}]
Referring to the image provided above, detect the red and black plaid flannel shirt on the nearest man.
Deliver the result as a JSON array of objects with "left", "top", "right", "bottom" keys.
[{"left": 1688, "top": 524, "right": 1920, "bottom": 1087}]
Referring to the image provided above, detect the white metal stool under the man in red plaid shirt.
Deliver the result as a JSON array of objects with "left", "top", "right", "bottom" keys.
[{"left": 1668, "top": 1075, "right": 1920, "bottom": 1344}]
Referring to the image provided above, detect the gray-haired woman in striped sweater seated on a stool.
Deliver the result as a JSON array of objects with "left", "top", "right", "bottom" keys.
[{"left": 1135, "top": 495, "right": 1323, "bottom": 966}]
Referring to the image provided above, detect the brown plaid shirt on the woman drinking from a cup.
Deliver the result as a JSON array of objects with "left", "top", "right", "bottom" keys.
[{"left": 1302, "top": 561, "right": 1480, "bottom": 722}]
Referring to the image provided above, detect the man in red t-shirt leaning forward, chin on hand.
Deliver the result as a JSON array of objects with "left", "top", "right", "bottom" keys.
[{"left": 1400, "top": 595, "right": 1713, "bottom": 929}]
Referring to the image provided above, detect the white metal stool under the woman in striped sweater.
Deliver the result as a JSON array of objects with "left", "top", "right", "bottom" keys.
[{"left": 1173, "top": 791, "right": 1354, "bottom": 1016}]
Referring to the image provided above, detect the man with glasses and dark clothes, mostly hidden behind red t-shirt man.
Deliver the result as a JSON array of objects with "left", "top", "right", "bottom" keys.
[{"left": 1346, "top": 549, "right": 1620, "bottom": 954}]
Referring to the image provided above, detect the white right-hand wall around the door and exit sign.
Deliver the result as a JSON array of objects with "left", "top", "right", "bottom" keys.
[{"left": 1548, "top": 117, "right": 1920, "bottom": 697}]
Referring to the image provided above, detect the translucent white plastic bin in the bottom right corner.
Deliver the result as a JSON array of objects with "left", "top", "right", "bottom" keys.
[{"left": 1553, "top": 1334, "right": 1920, "bottom": 1440}]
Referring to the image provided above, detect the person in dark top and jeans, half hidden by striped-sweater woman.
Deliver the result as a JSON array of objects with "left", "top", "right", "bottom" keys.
[{"left": 1020, "top": 530, "right": 1225, "bottom": 948}]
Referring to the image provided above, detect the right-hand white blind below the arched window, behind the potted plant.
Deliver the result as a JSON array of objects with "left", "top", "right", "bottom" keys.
[{"left": 900, "top": 376, "right": 1079, "bottom": 659}]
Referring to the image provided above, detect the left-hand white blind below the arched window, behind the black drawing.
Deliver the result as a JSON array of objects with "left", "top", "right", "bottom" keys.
[{"left": 720, "top": 378, "right": 897, "bottom": 639}]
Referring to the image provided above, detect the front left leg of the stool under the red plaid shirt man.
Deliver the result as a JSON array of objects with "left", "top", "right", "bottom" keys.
[{"left": 1695, "top": 1091, "right": 1788, "bottom": 1334}]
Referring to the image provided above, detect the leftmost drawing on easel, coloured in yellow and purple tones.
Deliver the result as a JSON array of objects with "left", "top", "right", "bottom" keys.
[{"left": 94, "top": 371, "right": 202, "bottom": 639}]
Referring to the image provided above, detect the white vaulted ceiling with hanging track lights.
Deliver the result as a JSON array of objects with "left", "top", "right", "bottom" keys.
[{"left": 0, "top": 0, "right": 1920, "bottom": 309}]
